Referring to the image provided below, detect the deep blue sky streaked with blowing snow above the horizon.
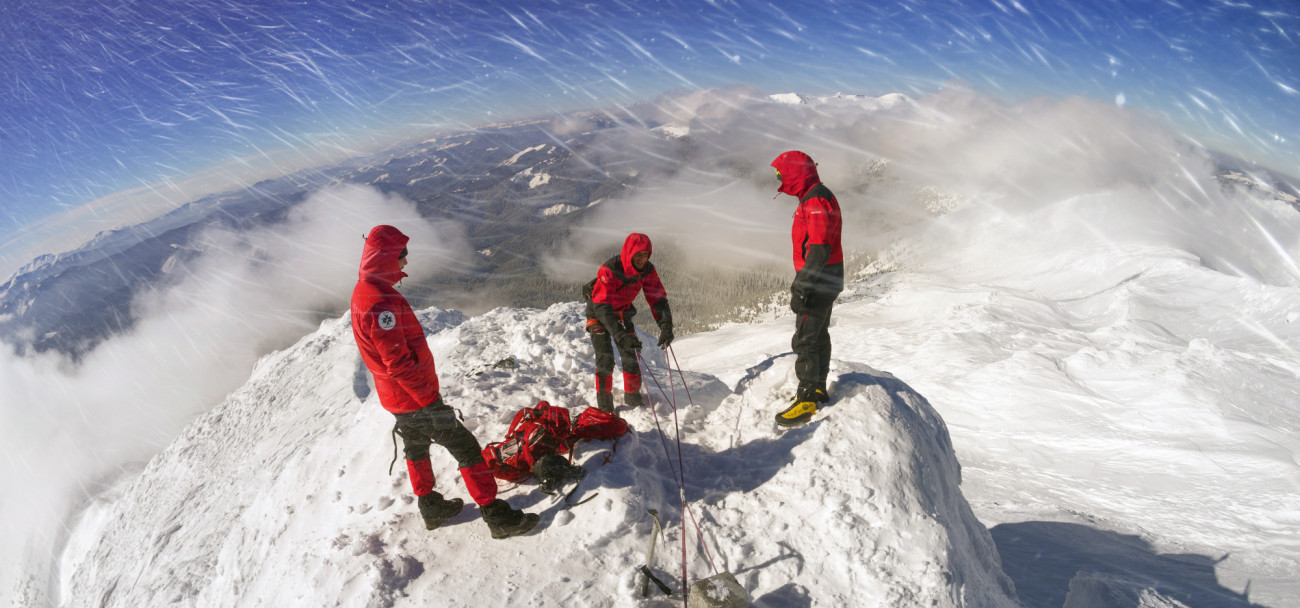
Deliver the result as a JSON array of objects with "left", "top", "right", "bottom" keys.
[{"left": 0, "top": 0, "right": 1300, "bottom": 247}]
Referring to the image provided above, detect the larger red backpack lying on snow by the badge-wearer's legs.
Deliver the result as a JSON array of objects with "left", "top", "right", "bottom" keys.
[{"left": 484, "top": 401, "right": 581, "bottom": 481}]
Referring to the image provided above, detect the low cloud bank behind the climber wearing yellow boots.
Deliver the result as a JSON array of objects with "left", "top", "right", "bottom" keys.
[{"left": 546, "top": 83, "right": 1300, "bottom": 291}]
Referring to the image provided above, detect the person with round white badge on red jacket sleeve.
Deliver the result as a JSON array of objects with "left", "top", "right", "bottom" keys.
[{"left": 351, "top": 226, "right": 538, "bottom": 538}]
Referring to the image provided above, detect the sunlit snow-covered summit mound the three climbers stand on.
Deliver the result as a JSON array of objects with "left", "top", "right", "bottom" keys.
[{"left": 60, "top": 303, "right": 1017, "bottom": 607}]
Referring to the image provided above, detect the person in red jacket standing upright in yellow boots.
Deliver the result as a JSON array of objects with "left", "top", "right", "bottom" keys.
[{"left": 772, "top": 149, "right": 844, "bottom": 426}]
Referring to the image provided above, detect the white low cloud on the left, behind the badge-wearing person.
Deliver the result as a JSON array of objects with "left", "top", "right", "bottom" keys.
[{"left": 0, "top": 186, "right": 469, "bottom": 595}]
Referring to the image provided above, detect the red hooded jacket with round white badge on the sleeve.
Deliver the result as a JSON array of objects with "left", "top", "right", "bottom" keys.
[{"left": 352, "top": 226, "right": 439, "bottom": 413}]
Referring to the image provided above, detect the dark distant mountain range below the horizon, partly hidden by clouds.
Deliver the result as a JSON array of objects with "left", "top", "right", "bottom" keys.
[{"left": 0, "top": 94, "right": 1300, "bottom": 359}]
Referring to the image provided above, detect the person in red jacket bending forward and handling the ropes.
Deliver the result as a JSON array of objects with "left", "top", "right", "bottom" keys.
[{"left": 586, "top": 233, "right": 673, "bottom": 413}]
